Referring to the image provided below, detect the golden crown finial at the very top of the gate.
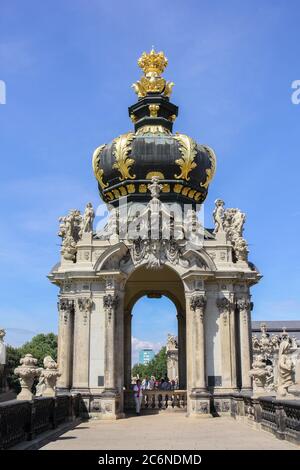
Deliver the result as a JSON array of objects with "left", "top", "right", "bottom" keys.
[{"left": 132, "top": 46, "right": 174, "bottom": 98}]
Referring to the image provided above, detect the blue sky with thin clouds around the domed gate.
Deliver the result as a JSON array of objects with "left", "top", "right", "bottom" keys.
[{"left": 0, "top": 0, "right": 300, "bottom": 352}]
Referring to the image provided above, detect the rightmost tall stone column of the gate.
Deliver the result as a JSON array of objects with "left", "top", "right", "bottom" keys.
[{"left": 237, "top": 298, "right": 252, "bottom": 391}]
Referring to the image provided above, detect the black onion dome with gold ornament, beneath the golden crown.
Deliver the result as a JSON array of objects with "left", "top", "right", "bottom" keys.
[{"left": 93, "top": 51, "right": 216, "bottom": 205}]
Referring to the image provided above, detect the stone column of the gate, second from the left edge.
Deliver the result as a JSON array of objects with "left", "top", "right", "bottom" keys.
[{"left": 72, "top": 297, "right": 93, "bottom": 392}]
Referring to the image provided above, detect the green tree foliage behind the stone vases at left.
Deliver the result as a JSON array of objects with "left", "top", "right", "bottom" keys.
[{"left": 6, "top": 333, "right": 57, "bottom": 393}]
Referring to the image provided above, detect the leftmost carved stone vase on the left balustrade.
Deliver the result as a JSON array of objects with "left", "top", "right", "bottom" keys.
[{"left": 14, "top": 354, "right": 41, "bottom": 400}]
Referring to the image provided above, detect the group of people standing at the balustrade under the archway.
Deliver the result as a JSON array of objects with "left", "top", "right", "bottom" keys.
[{"left": 133, "top": 375, "right": 179, "bottom": 415}]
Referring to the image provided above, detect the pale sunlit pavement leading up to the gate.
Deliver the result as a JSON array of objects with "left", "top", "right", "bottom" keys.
[{"left": 42, "top": 413, "right": 299, "bottom": 450}]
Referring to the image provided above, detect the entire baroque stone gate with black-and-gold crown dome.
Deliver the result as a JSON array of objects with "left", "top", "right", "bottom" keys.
[{"left": 49, "top": 50, "right": 260, "bottom": 419}]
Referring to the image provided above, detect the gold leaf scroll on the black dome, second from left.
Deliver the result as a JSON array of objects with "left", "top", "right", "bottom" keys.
[{"left": 113, "top": 132, "right": 135, "bottom": 181}]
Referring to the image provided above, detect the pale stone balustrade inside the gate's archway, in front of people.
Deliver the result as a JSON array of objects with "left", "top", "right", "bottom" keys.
[{"left": 124, "top": 390, "right": 187, "bottom": 411}]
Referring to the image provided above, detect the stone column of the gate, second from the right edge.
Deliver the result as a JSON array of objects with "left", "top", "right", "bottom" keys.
[{"left": 217, "top": 297, "right": 232, "bottom": 389}]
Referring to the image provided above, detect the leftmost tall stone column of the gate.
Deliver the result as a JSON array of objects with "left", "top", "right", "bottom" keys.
[{"left": 57, "top": 298, "right": 74, "bottom": 392}]
